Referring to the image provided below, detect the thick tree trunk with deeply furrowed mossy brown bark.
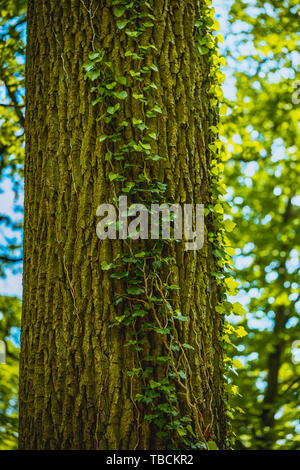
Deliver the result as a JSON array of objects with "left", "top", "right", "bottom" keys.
[{"left": 20, "top": 0, "right": 226, "bottom": 449}]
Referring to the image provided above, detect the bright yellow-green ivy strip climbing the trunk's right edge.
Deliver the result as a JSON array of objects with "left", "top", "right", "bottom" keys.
[{"left": 196, "top": 0, "right": 247, "bottom": 448}]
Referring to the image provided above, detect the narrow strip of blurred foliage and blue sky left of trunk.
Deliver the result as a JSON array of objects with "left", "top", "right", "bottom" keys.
[{"left": 0, "top": 0, "right": 26, "bottom": 450}]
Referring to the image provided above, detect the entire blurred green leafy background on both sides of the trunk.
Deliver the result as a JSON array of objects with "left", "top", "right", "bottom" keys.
[{"left": 0, "top": 0, "right": 300, "bottom": 450}]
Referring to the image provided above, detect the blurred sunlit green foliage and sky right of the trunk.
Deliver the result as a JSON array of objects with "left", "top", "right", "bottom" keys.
[{"left": 223, "top": 0, "right": 300, "bottom": 450}]
